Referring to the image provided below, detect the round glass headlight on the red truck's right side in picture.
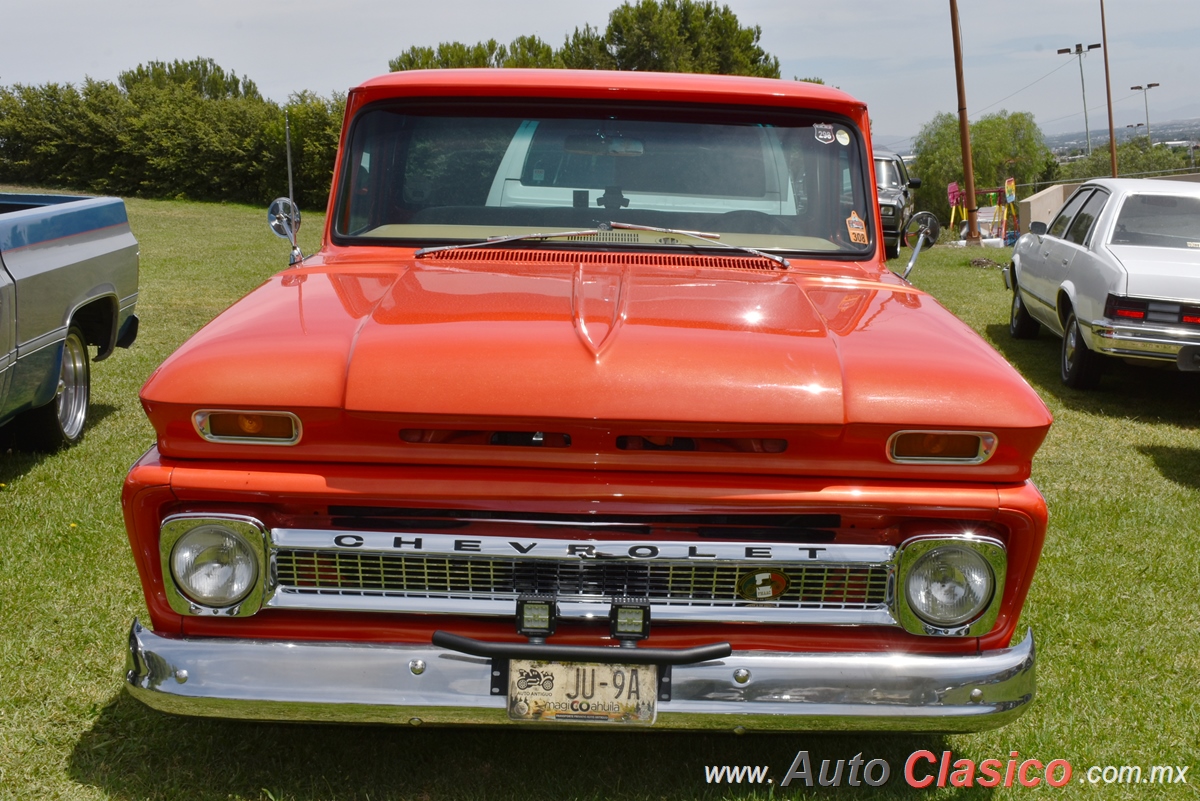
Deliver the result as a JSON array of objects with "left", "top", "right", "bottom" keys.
[{"left": 905, "top": 546, "right": 995, "bottom": 627}]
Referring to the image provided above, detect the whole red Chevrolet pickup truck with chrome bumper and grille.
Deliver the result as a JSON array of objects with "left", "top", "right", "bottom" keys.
[{"left": 124, "top": 70, "right": 1051, "bottom": 731}]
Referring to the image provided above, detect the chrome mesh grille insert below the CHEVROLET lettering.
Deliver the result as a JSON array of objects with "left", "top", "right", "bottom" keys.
[{"left": 275, "top": 548, "right": 889, "bottom": 609}]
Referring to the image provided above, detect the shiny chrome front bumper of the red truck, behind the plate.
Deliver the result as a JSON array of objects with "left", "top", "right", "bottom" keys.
[{"left": 126, "top": 621, "right": 1034, "bottom": 731}]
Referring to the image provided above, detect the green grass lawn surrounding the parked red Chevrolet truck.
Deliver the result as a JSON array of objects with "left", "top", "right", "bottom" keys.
[{"left": 0, "top": 195, "right": 1200, "bottom": 801}]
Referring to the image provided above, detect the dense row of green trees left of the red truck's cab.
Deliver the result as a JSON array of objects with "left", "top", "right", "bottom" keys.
[{"left": 0, "top": 59, "right": 346, "bottom": 209}]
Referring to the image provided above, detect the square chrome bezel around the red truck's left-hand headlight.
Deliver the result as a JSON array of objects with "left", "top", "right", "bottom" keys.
[{"left": 158, "top": 514, "right": 268, "bottom": 618}]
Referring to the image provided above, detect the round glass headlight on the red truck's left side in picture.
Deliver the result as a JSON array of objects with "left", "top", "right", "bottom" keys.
[{"left": 170, "top": 524, "right": 258, "bottom": 607}]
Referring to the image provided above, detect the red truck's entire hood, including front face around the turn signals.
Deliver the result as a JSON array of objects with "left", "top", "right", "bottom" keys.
[{"left": 142, "top": 251, "right": 1051, "bottom": 481}]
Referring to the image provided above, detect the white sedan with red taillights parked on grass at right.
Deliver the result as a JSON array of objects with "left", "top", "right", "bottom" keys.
[{"left": 1004, "top": 179, "right": 1200, "bottom": 390}]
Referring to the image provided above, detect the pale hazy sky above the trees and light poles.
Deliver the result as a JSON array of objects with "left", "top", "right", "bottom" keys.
[{"left": 0, "top": 0, "right": 1200, "bottom": 144}]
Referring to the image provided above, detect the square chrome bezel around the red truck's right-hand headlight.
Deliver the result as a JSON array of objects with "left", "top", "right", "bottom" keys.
[{"left": 895, "top": 534, "right": 1008, "bottom": 637}]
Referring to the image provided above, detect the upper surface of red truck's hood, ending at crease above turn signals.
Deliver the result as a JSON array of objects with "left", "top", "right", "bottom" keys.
[{"left": 143, "top": 251, "right": 1049, "bottom": 428}]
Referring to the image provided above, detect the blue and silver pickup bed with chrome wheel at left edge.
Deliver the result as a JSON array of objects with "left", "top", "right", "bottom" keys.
[{"left": 0, "top": 194, "right": 138, "bottom": 450}]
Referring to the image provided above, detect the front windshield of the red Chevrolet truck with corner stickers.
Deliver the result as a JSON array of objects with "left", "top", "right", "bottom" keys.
[{"left": 335, "top": 101, "right": 874, "bottom": 255}]
